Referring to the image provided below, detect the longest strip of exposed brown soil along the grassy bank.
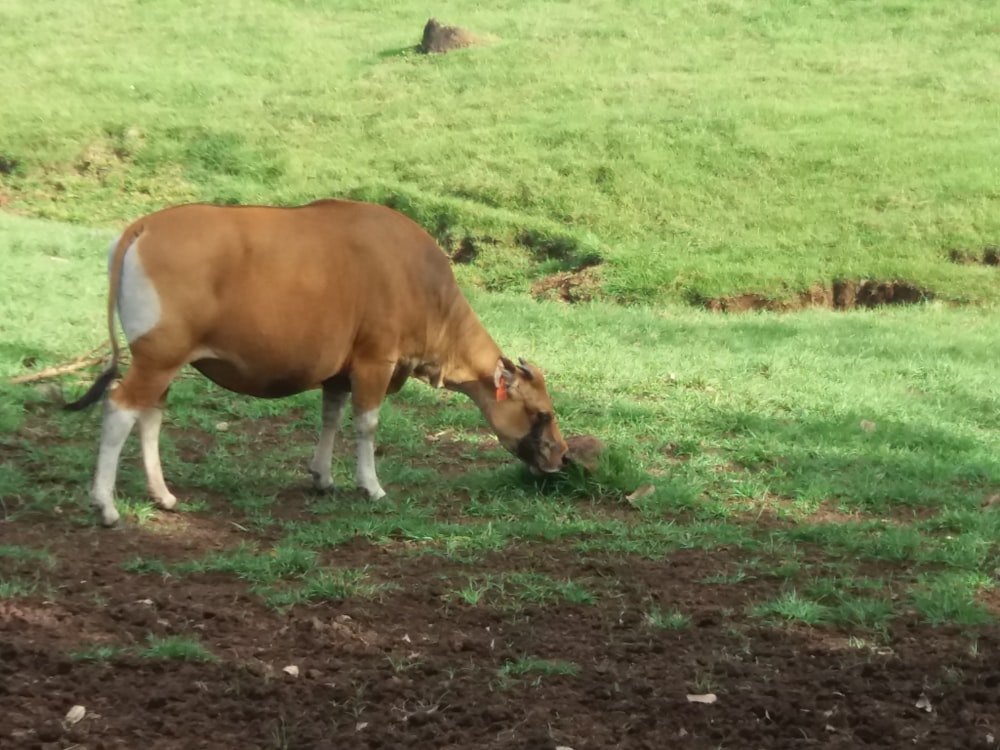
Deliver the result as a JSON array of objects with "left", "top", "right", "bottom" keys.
[{"left": 696, "top": 279, "right": 935, "bottom": 312}]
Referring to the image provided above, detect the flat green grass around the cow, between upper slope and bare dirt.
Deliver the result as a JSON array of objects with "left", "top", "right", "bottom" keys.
[{"left": 0, "top": 209, "right": 1000, "bottom": 619}]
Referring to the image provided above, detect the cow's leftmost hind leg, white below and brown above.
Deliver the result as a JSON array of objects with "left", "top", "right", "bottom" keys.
[{"left": 91, "top": 360, "right": 177, "bottom": 526}]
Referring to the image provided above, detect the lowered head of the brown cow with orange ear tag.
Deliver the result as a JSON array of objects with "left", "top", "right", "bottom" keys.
[{"left": 491, "top": 357, "right": 566, "bottom": 473}]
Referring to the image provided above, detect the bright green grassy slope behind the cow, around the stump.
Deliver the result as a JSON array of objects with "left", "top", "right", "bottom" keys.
[{"left": 0, "top": 0, "right": 1000, "bottom": 301}]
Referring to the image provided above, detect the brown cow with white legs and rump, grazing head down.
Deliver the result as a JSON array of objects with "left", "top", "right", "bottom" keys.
[{"left": 67, "top": 200, "right": 566, "bottom": 525}]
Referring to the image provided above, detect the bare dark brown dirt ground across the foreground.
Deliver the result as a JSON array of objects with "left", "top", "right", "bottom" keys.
[{"left": 0, "top": 500, "right": 1000, "bottom": 750}]
